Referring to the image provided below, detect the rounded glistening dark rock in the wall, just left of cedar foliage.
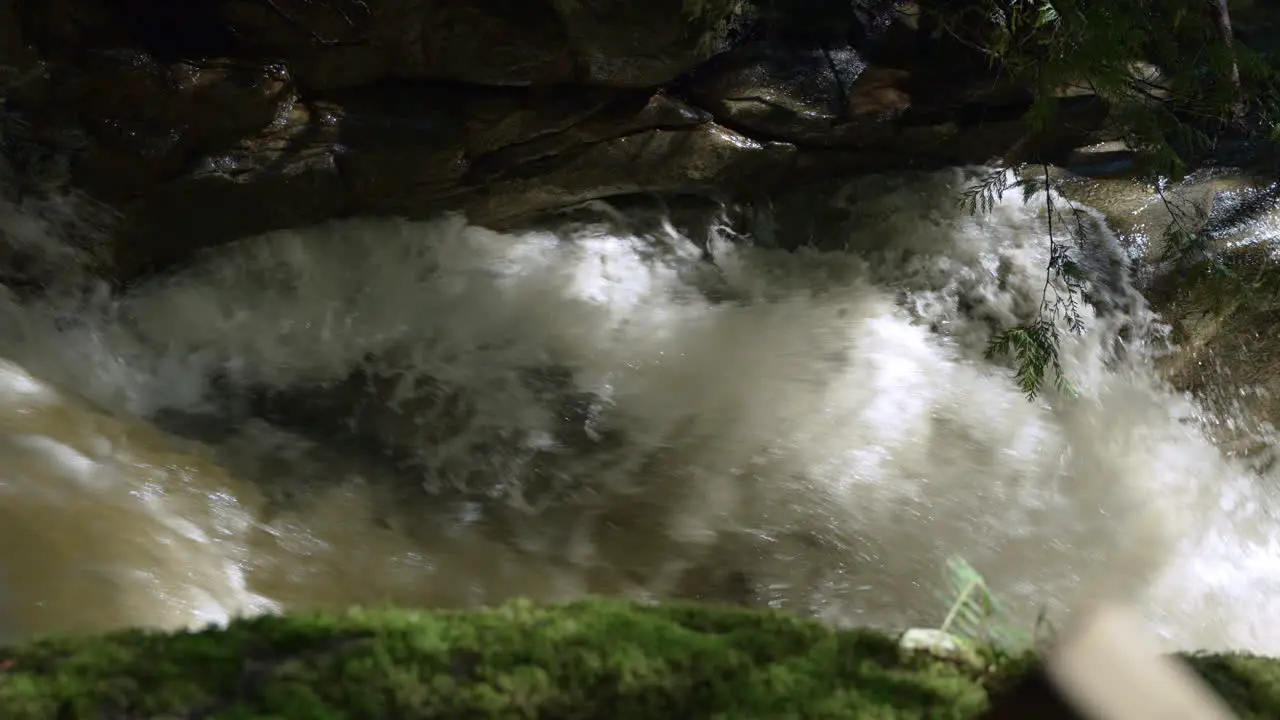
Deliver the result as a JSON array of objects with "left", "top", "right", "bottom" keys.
[{"left": 687, "top": 31, "right": 1107, "bottom": 159}]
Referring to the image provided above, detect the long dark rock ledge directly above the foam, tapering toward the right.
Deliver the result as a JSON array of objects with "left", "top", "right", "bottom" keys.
[{"left": 118, "top": 83, "right": 778, "bottom": 263}]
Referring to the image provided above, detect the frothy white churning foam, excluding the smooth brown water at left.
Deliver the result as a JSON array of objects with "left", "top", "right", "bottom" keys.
[{"left": 0, "top": 166, "right": 1280, "bottom": 652}]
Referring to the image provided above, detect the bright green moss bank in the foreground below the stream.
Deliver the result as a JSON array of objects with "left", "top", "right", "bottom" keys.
[{"left": 0, "top": 601, "right": 1280, "bottom": 720}]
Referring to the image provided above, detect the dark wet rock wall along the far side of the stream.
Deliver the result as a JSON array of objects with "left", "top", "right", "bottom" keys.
[{"left": 0, "top": 0, "right": 1105, "bottom": 277}]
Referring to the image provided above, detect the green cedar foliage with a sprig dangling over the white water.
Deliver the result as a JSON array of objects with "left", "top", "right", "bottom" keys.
[{"left": 922, "top": 0, "right": 1280, "bottom": 398}]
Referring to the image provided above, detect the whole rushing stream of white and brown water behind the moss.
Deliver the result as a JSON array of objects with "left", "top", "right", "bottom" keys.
[{"left": 0, "top": 166, "right": 1280, "bottom": 652}]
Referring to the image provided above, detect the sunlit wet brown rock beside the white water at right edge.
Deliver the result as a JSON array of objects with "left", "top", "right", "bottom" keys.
[{"left": 1059, "top": 170, "right": 1280, "bottom": 469}]
